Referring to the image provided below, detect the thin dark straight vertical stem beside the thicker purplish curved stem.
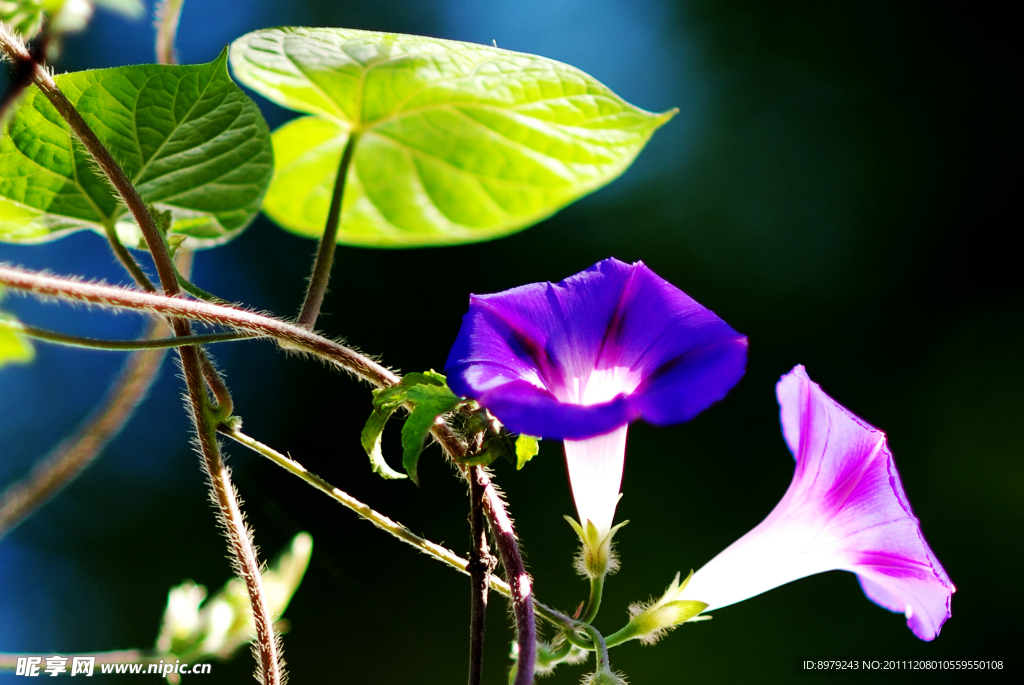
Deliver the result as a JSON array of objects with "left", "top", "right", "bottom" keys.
[{"left": 468, "top": 466, "right": 497, "bottom": 685}]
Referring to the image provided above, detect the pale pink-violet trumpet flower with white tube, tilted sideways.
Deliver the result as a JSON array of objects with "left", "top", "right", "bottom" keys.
[{"left": 683, "top": 366, "right": 955, "bottom": 640}]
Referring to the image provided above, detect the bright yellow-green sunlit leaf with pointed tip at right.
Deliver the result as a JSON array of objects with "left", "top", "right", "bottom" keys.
[{"left": 231, "top": 28, "right": 674, "bottom": 247}]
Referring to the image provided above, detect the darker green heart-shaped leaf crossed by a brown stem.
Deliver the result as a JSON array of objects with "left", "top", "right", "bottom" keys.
[{"left": 0, "top": 51, "right": 273, "bottom": 248}]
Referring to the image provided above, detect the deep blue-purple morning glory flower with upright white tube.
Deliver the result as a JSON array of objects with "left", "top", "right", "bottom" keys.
[{"left": 445, "top": 258, "right": 746, "bottom": 538}]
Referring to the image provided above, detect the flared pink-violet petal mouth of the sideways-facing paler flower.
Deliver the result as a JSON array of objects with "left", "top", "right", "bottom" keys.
[{"left": 777, "top": 366, "right": 954, "bottom": 640}]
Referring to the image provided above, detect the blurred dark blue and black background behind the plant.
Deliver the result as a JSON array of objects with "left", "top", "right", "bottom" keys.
[{"left": 0, "top": 0, "right": 1024, "bottom": 685}]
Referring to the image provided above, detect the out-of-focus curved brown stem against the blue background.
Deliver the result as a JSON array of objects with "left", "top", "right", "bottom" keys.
[{"left": 0, "top": 319, "right": 168, "bottom": 538}]
